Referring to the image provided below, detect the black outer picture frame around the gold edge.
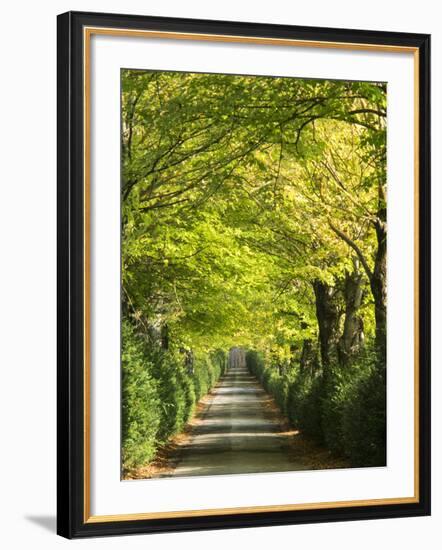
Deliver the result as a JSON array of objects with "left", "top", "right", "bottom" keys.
[{"left": 57, "top": 12, "right": 430, "bottom": 538}]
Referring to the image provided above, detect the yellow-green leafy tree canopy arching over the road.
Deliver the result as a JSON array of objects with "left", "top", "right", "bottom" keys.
[{"left": 122, "top": 70, "right": 386, "bottom": 362}]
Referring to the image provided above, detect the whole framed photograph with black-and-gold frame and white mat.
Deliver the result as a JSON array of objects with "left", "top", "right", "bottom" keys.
[{"left": 58, "top": 12, "right": 430, "bottom": 538}]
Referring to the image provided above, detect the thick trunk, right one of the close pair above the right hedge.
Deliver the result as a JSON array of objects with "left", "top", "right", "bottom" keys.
[{"left": 338, "top": 261, "right": 364, "bottom": 366}]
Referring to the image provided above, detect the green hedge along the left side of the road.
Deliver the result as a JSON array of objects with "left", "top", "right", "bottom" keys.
[{"left": 122, "top": 319, "right": 226, "bottom": 471}]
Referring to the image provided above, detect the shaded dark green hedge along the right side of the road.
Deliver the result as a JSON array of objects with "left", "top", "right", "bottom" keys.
[{"left": 246, "top": 349, "right": 386, "bottom": 467}]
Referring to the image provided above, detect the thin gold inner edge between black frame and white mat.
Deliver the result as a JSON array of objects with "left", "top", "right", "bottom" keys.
[{"left": 83, "top": 27, "right": 419, "bottom": 523}]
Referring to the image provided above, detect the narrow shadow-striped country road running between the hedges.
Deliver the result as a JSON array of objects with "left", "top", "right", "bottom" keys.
[{"left": 172, "top": 366, "right": 305, "bottom": 476}]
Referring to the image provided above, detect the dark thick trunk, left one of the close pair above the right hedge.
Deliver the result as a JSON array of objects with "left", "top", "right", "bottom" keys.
[{"left": 313, "top": 281, "right": 340, "bottom": 370}]
